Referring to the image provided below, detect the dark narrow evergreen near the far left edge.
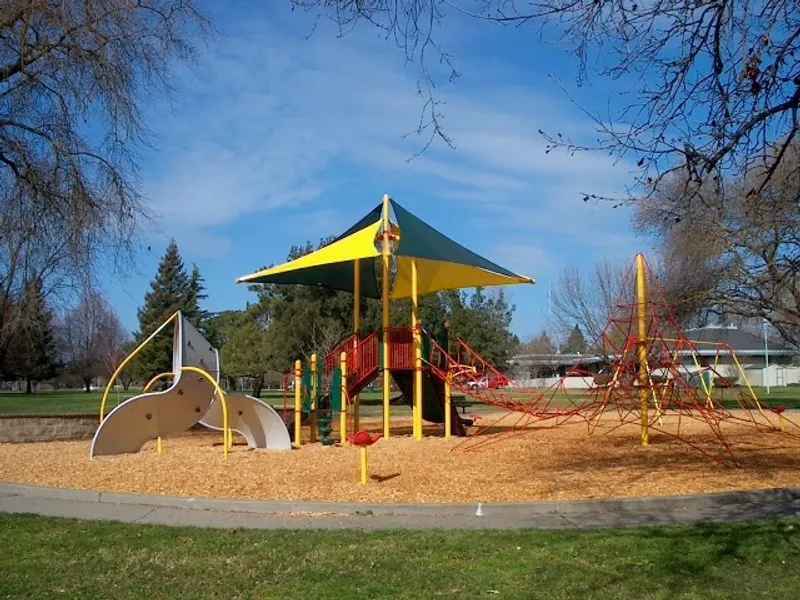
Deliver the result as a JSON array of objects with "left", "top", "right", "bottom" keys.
[{"left": 9, "top": 280, "right": 57, "bottom": 394}]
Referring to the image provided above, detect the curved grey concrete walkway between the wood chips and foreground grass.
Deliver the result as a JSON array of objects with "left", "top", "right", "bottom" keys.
[{"left": 0, "top": 483, "right": 800, "bottom": 530}]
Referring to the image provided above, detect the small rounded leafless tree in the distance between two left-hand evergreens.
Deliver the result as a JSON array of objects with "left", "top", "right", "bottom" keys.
[{"left": 60, "top": 292, "right": 121, "bottom": 392}]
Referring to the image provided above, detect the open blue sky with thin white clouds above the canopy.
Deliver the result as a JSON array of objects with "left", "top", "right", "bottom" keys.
[{"left": 108, "top": 2, "right": 647, "bottom": 337}]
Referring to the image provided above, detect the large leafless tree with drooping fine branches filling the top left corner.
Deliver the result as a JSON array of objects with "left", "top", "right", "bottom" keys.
[{"left": 0, "top": 0, "right": 209, "bottom": 370}]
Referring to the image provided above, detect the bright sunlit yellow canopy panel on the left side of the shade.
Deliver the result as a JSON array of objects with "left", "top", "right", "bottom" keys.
[{"left": 236, "top": 221, "right": 381, "bottom": 283}]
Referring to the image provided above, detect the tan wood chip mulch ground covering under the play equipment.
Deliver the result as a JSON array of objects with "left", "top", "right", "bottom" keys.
[{"left": 0, "top": 410, "right": 800, "bottom": 502}]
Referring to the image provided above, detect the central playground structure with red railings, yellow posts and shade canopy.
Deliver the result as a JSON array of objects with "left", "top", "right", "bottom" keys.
[{"left": 237, "top": 196, "right": 534, "bottom": 446}]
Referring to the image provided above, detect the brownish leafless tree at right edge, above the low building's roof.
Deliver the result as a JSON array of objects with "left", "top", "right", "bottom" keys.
[{"left": 636, "top": 142, "right": 800, "bottom": 346}]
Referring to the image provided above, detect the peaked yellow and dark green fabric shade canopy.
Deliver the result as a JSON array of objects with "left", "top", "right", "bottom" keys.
[{"left": 237, "top": 200, "right": 534, "bottom": 298}]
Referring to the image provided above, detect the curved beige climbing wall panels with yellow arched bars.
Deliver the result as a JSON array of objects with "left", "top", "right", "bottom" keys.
[{"left": 89, "top": 312, "right": 291, "bottom": 457}]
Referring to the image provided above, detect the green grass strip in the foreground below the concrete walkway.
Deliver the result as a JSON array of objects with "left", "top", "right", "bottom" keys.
[{"left": 0, "top": 515, "right": 800, "bottom": 600}]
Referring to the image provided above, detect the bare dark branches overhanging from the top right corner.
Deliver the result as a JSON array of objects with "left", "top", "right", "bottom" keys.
[{"left": 291, "top": 0, "right": 800, "bottom": 211}]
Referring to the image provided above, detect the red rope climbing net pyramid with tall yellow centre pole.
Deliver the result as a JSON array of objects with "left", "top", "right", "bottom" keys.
[{"left": 444, "top": 254, "right": 800, "bottom": 465}]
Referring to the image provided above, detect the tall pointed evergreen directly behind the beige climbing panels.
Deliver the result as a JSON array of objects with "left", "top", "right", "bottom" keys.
[{"left": 135, "top": 240, "right": 205, "bottom": 379}]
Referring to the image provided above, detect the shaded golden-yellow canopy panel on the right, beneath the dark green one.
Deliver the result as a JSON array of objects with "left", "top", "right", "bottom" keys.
[{"left": 392, "top": 256, "right": 535, "bottom": 299}]
